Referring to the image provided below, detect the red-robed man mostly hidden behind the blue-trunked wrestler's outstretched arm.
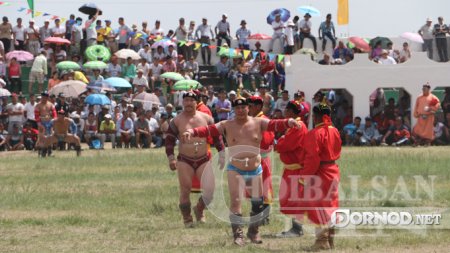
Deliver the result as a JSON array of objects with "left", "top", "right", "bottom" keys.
[{"left": 247, "top": 96, "right": 275, "bottom": 224}]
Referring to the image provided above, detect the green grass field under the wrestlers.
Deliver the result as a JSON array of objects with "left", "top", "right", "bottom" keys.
[{"left": 0, "top": 147, "right": 450, "bottom": 252}]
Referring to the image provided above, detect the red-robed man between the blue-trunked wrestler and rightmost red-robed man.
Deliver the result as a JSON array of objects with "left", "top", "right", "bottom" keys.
[{"left": 275, "top": 100, "right": 308, "bottom": 238}]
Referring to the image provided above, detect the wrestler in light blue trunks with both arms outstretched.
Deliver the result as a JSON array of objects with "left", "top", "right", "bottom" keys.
[{"left": 182, "top": 98, "right": 300, "bottom": 246}]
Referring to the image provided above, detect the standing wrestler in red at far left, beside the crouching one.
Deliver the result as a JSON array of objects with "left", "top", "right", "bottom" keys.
[{"left": 34, "top": 91, "right": 56, "bottom": 157}]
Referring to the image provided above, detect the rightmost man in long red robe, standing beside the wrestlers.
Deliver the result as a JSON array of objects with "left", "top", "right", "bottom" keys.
[{"left": 299, "top": 104, "right": 342, "bottom": 251}]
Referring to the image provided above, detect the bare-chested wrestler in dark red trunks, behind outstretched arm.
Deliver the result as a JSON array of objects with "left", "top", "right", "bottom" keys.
[{"left": 166, "top": 92, "right": 224, "bottom": 227}]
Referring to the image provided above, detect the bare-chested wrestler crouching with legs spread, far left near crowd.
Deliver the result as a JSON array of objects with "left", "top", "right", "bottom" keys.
[{"left": 44, "top": 110, "right": 81, "bottom": 156}]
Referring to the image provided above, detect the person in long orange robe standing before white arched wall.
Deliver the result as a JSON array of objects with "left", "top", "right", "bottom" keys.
[{"left": 412, "top": 83, "right": 440, "bottom": 146}]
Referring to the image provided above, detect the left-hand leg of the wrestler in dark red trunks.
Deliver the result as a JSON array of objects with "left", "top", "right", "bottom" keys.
[{"left": 177, "top": 161, "right": 194, "bottom": 227}]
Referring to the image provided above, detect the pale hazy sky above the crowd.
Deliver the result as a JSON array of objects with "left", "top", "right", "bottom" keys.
[{"left": 0, "top": 0, "right": 450, "bottom": 37}]
